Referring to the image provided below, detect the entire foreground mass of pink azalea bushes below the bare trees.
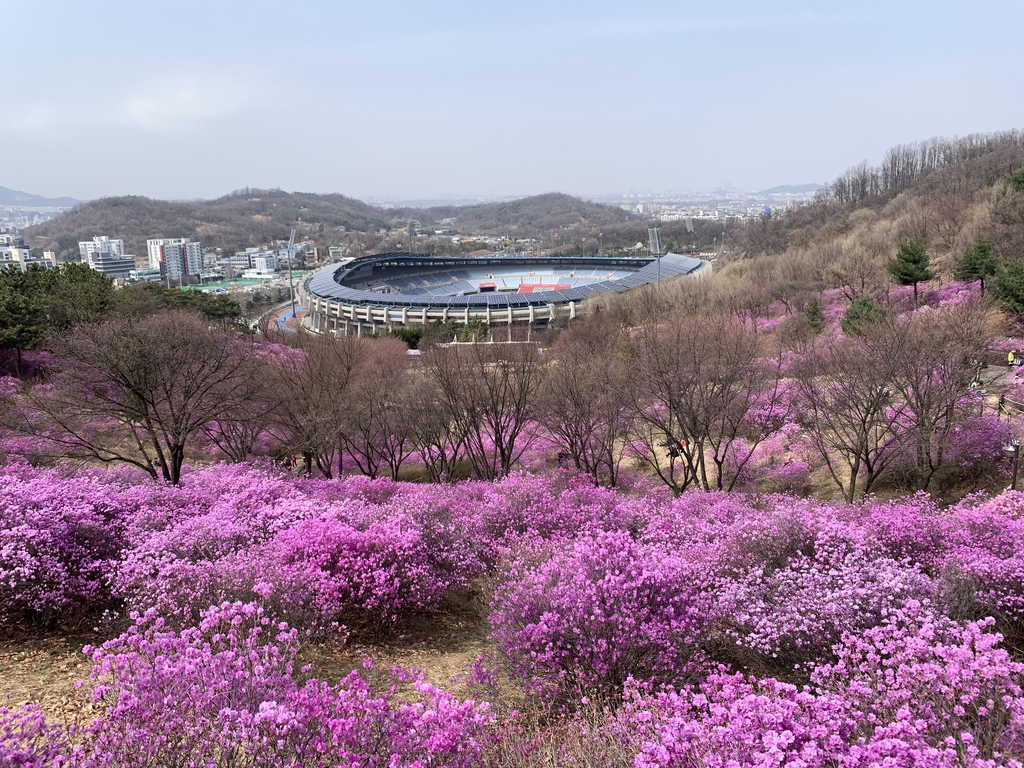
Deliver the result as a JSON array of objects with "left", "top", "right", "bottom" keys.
[{"left": 0, "top": 464, "right": 1024, "bottom": 768}]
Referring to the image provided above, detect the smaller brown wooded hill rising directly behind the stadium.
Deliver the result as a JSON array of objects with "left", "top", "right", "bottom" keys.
[{"left": 393, "top": 193, "right": 637, "bottom": 238}]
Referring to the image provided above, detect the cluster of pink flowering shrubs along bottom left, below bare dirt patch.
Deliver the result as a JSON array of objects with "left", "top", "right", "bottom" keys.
[{"left": 0, "top": 603, "right": 490, "bottom": 768}]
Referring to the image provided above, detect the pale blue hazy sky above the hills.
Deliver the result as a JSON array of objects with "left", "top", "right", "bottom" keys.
[{"left": 0, "top": 0, "right": 1024, "bottom": 200}]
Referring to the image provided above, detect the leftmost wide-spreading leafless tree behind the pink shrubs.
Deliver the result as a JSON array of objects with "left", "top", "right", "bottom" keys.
[{"left": 8, "top": 311, "right": 258, "bottom": 484}]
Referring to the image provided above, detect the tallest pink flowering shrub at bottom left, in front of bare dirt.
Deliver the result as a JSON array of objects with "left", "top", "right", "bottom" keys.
[{"left": 85, "top": 603, "right": 298, "bottom": 765}]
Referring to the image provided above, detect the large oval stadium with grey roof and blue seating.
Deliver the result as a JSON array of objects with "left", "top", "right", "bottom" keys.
[{"left": 300, "top": 253, "right": 711, "bottom": 336}]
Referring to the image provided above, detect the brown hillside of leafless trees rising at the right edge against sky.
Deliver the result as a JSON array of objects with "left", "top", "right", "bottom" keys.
[{"left": 731, "top": 130, "right": 1024, "bottom": 267}]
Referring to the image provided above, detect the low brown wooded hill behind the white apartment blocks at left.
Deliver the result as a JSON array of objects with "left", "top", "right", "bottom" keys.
[{"left": 25, "top": 189, "right": 386, "bottom": 259}]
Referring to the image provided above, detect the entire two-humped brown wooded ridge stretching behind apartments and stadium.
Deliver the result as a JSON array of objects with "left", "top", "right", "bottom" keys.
[{"left": 25, "top": 189, "right": 635, "bottom": 259}]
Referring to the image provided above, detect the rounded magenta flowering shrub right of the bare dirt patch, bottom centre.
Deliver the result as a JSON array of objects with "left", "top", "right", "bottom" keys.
[{"left": 490, "top": 532, "right": 711, "bottom": 698}]
